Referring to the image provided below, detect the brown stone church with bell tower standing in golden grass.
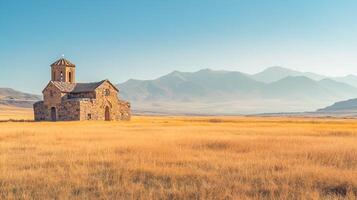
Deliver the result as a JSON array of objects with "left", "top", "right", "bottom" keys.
[{"left": 33, "top": 58, "right": 131, "bottom": 121}]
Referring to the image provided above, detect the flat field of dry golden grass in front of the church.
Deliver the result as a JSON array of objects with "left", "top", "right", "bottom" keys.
[{"left": 0, "top": 106, "right": 357, "bottom": 200}]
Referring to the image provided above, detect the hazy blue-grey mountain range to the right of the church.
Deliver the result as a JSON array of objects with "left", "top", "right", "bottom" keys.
[{"left": 118, "top": 67, "right": 357, "bottom": 114}]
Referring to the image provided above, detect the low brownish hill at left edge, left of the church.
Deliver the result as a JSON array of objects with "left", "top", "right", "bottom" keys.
[{"left": 0, "top": 88, "right": 41, "bottom": 107}]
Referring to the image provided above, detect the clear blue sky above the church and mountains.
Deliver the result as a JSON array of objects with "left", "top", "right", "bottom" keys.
[{"left": 0, "top": 0, "right": 357, "bottom": 93}]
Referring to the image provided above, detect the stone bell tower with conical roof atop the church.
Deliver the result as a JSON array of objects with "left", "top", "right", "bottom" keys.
[{"left": 51, "top": 58, "right": 76, "bottom": 83}]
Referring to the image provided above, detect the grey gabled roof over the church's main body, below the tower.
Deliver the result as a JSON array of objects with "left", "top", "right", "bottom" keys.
[{"left": 44, "top": 80, "right": 119, "bottom": 93}]
